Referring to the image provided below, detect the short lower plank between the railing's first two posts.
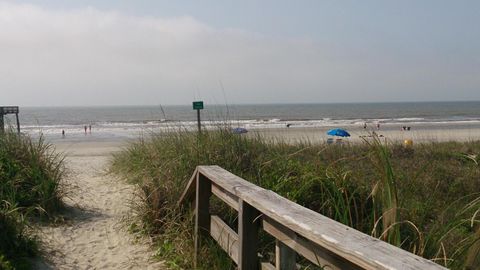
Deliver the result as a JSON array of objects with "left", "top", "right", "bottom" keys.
[{"left": 210, "top": 216, "right": 239, "bottom": 264}]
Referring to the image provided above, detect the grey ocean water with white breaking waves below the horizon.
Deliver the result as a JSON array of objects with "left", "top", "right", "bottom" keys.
[{"left": 7, "top": 102, "right": 480, "bottom": 139}]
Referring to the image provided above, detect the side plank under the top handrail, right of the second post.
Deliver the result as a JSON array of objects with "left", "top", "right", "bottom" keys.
[{"left": 263, "top": 217, "right": 363, "bottom": 270}]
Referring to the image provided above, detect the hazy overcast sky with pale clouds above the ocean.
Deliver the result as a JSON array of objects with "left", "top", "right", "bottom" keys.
[{"left": 0, "top": 0, "right": 480, "bottom": 106}]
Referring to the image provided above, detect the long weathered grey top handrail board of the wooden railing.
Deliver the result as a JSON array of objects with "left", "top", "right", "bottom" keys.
[{"left": 198, "top": 166, "right": 446, "bottom": 270}]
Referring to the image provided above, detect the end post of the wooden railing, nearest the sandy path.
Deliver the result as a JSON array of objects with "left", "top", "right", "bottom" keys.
[{"left": 194, "top": 173, "right": 212, "bottom": 269}]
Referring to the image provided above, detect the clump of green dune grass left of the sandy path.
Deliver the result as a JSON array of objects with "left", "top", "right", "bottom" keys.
[{"left": 0, "top": 131, "right": 65, "bottom": 269}]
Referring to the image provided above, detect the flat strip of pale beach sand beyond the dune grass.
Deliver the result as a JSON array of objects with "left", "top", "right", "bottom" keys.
[{"left": 38, "top": 125, "right": 480, "bottom": 147}]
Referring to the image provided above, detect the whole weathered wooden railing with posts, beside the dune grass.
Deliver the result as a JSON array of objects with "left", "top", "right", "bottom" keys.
[{"left": 179, "top": 166, "right": 445, "bottom": 270}]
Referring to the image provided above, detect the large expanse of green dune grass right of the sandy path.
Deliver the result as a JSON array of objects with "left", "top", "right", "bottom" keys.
[{"left": 111, "top": 129, "right": 480, "bottom": 269}]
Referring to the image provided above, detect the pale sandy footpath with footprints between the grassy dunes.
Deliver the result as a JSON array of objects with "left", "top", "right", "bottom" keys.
[{"left": 36, "top": 142, "right": 165, "bottom": 270}]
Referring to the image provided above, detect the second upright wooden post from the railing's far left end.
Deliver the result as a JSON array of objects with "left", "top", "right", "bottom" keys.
[{"left": 238, "top": 200, "right": 261, "bottom": 270}]
